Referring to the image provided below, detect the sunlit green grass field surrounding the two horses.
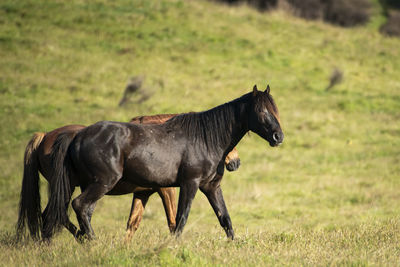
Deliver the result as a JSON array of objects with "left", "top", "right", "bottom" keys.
[{"left": 0, "top": 0, "right": 400, "bottom": 266}]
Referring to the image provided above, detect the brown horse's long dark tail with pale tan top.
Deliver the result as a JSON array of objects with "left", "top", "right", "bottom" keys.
[{"left": 16, "top": 133, "right": 46, "bottom": 239}]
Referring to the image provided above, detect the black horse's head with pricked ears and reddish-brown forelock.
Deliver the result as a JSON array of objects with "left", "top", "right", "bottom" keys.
[{"left": 248, "top": 85, "right": 283, "bottom": 146}]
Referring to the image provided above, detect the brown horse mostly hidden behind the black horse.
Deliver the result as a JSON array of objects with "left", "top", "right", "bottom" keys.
[{"left": 17, "top": 114, "right": 240, "bottom": 241}]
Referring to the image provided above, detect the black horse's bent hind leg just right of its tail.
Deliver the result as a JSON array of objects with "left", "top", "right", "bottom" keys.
[{"left": 72, "top": 180, "right": 117, "bottom": 240}]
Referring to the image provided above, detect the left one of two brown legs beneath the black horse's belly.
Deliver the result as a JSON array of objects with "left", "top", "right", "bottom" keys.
[{"left": 125, "top": 191, "right": 154, "bottom": 242}]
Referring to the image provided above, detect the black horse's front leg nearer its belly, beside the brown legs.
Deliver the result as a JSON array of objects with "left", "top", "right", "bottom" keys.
[{"left": 174, "top": 179, "right": 199, "bottom": 237}]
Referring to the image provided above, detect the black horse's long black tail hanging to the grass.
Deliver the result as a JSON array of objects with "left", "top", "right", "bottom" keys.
[{"left": 42, "top": 132, "right": 76, "bottom": 239}]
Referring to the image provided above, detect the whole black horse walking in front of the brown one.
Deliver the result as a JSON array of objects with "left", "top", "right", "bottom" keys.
[{"left": 43, "top": 86, "right": 283, "bottom": 242}]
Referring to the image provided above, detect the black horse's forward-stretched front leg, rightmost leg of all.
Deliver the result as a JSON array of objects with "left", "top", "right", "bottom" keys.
[{"left": 200, "top": 182, "right": 235, "bottom": 240}]
